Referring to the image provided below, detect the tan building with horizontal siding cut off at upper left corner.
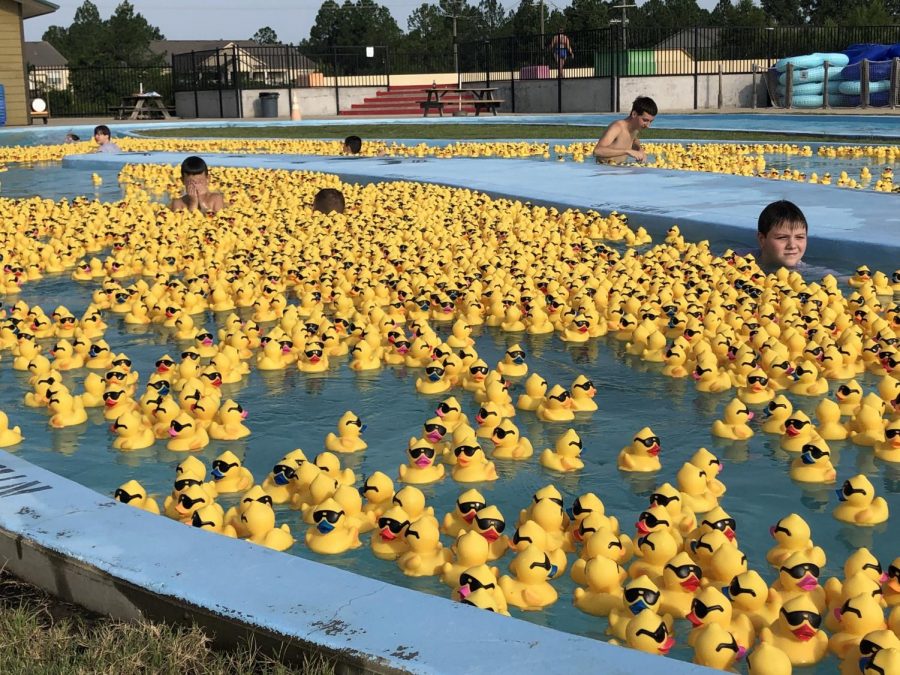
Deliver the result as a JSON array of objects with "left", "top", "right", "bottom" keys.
[{"left": 0, "top": 0, "right": 59, "bottom": 125}]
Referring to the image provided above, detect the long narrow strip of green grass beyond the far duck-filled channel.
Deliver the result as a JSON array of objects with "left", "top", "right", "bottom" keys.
[{"left": 140, "top": 124, "right": 884, "bottom": 143}]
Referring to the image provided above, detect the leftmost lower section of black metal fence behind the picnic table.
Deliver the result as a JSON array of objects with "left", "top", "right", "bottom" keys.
[{"left": 28, "top": 65, "right": 175, "bottom": 117}]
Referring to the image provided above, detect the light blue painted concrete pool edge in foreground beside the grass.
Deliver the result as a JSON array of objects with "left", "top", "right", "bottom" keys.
[{"left": 0, "top": 451, "right": 713, "bottom": 675}]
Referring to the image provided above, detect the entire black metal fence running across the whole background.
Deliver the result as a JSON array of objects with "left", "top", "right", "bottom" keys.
[{"left": 28, "top": 24, "right": 900, "bottom": 117}]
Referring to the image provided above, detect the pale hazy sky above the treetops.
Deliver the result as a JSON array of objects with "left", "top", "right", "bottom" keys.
[{"left": 25, "top": 0, "right": 716, "bottom": 43}]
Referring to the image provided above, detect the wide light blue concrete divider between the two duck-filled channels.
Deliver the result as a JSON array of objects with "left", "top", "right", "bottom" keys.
[{"left": 63, "top": 152, "right": 900, "bottom": 273}]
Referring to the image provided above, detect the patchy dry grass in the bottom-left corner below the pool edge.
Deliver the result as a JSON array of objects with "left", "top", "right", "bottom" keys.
[{"left": 0, "top": 570, "right": 334, "bottom": 675}]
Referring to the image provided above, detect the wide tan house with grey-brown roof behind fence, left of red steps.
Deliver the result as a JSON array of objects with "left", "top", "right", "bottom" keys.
[{"left": 150, "top": 40, "right": 318, "bottom": 87}]
